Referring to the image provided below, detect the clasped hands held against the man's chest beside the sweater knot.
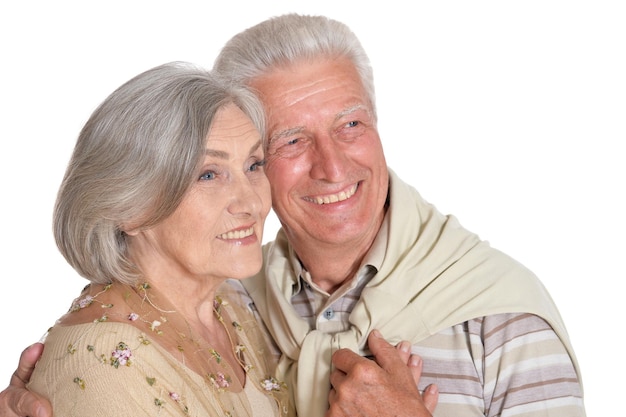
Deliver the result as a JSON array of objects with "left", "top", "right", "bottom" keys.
[{"left": 326, "top": 330, "right": 439, "bottom": 417}]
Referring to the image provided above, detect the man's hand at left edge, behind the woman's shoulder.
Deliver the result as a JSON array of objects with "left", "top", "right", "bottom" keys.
[{"left": 0, "top": 343, "right": 52, "bottom": 417}]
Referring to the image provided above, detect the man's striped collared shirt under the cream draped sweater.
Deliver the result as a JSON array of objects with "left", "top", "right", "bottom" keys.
[{"left": 291, "top": 265, "right": 585, "bottom": 417}]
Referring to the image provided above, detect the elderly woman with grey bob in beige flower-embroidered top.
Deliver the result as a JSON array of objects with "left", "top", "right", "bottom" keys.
[{"left": 24, "top": 63, "right": 288, "bottom": 416}]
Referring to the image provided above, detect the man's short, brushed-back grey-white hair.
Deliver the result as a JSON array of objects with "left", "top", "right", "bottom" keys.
[{"left": 213, "top": 13, "right": 376, "bottom": 117}]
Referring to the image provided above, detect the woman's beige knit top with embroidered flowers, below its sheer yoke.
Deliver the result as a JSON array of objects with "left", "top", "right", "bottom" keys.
[{"left": 29, "top": 282, "right": 281, "bottom": 417}]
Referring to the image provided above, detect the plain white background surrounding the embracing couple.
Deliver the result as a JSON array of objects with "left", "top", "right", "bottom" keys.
[{"left": 0, "top": 0, "right": 626, "bottom": 416}]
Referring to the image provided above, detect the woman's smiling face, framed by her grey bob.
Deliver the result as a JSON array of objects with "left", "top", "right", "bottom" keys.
[{"left": 129, "top": 104, "right": 271, "bottom": 285}]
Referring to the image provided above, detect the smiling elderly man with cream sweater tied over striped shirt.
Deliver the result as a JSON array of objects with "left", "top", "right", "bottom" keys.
[{"left": 1, "top": 14, "right": 585, "bottom": 417}]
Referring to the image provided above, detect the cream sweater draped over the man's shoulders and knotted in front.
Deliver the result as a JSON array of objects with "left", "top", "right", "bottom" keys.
[{"left": 243, "top": 171, "right": 578, "bottom": 417}]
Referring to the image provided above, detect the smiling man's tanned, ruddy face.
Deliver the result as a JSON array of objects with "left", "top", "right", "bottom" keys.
[{"left": 251, "top": 58, "right": 388, "bottom": 247}]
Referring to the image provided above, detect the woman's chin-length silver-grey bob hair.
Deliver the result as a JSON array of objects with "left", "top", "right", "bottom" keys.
[{"left": 53, "top": 62, "right": 265, "bottom": 284}]
